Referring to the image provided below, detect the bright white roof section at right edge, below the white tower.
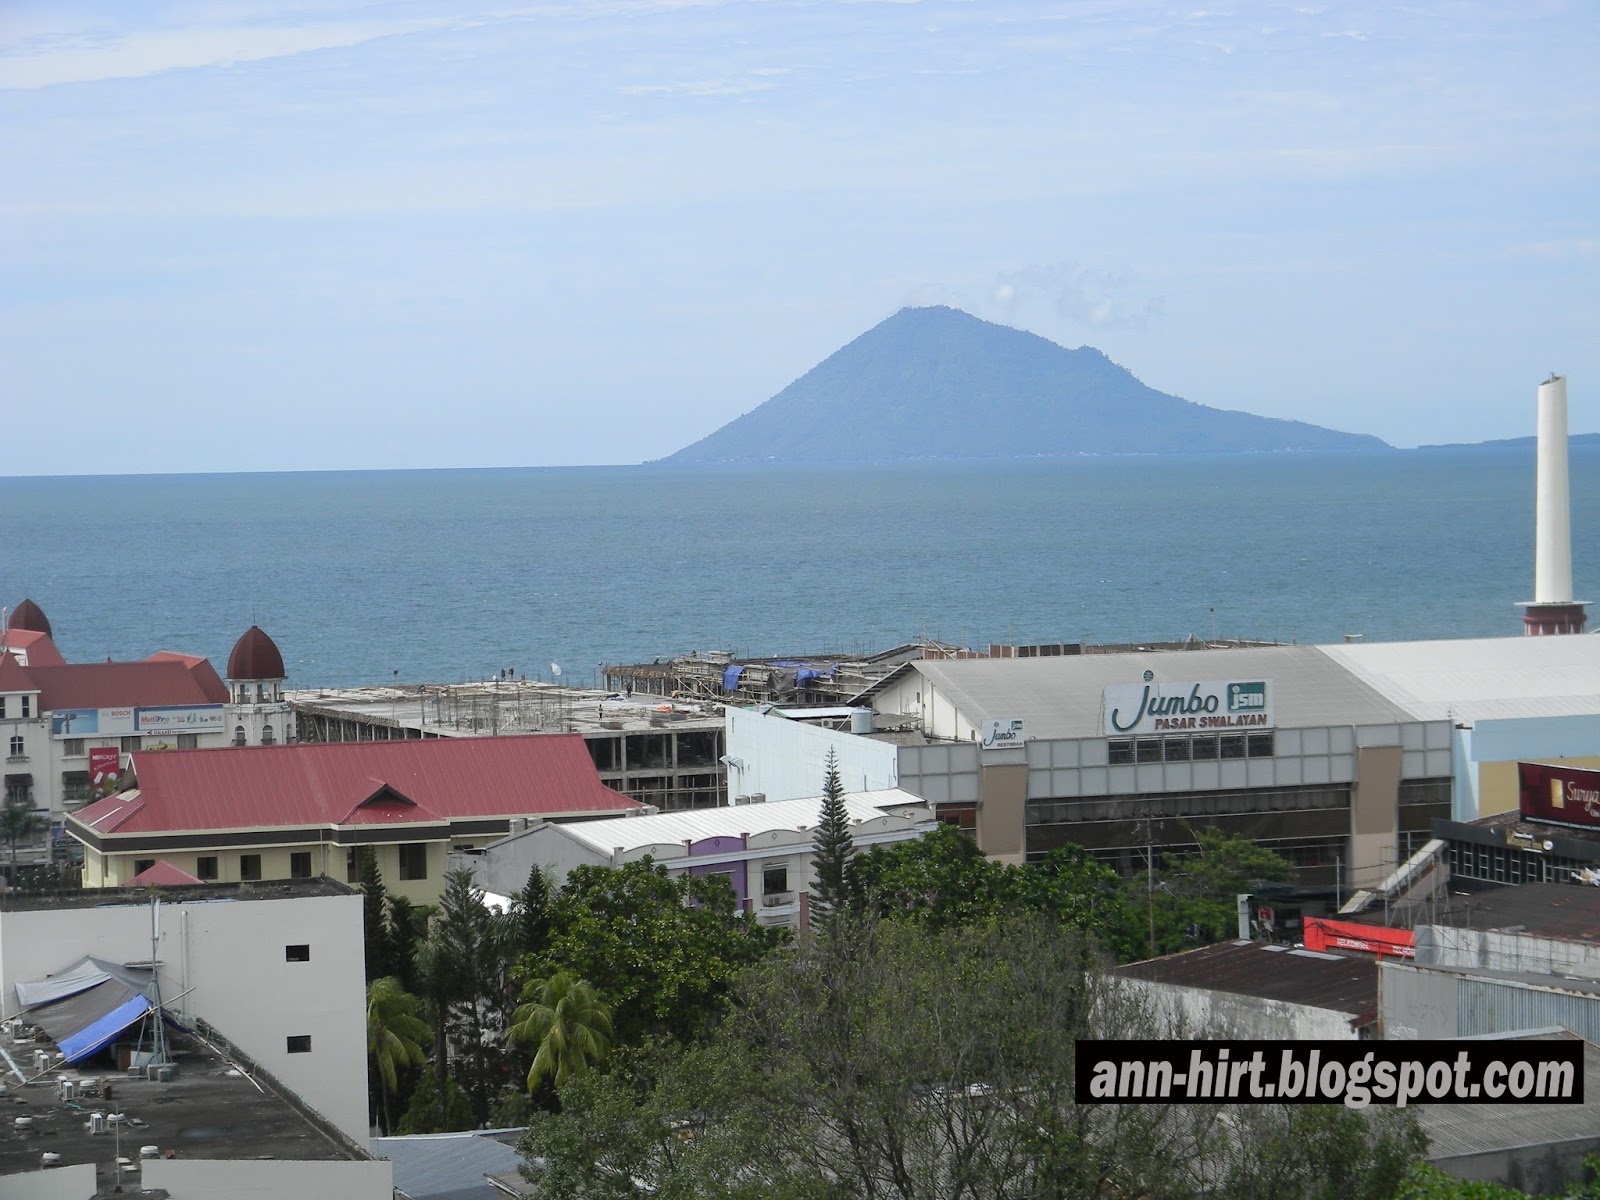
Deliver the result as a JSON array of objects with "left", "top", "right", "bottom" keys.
[{"left": 1320, "top": 635, "right": 1600, "bottom": 722}]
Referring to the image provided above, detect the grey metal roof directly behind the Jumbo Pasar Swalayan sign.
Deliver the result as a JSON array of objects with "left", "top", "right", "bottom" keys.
[{"left": 907, "top": 646, "right": 1410, "bottom": 738}]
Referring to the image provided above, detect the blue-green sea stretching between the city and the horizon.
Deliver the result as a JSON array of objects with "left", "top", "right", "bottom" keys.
[{"left": 0, "top": 445, "right": 1600, "bottom": 688}]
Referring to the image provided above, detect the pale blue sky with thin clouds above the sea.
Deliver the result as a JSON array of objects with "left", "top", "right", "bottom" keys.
[{"left": 0, "top": 0, "right": 1600, "bottom": 475}]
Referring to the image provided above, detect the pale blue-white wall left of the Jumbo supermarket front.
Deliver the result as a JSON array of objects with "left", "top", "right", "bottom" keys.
[{"left": 726, "top": 707, "right": 899, "bottom": 800}]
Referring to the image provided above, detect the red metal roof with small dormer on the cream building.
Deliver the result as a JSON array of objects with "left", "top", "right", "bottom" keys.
[{"left": 72, "top": 733, "right": 638, "bottom": 835}]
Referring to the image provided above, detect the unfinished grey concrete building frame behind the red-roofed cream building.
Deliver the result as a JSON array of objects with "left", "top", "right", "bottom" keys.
[{"left": 286, "top": 678, "right": 728, "bottom": 810}]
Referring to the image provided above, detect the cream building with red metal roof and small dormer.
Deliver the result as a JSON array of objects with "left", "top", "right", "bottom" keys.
[{"left": 67, "top": 734, "right": 638, "bottom": 904}]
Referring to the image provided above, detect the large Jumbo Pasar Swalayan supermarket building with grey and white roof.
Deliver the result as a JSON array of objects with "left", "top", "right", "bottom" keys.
[{"left": 728, "top": 637, "right": 1600, "bottom": 898}]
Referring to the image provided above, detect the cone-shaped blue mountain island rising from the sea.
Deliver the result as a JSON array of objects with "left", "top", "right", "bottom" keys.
[{"left": 661, "top": 309, "right": 1389, "bottom": 466}]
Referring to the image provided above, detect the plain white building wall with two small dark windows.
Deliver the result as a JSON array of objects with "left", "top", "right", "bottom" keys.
[{"left": 0, "top": 896, "right": 370, "bottom": 1142}]
